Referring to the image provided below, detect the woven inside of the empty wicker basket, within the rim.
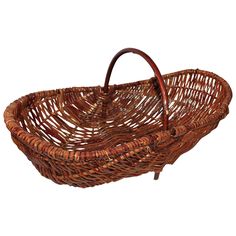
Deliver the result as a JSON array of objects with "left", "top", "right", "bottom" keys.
[{"left": 17, "top": 70, "right": 223, "bottom": 151}]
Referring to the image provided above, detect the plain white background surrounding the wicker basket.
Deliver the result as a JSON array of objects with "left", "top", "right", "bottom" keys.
[{"left": 0, "top": 0, "right": 236, "bottom": 236}]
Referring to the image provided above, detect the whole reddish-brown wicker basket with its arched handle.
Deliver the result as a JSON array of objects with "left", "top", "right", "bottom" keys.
[{"left": 4, "top": 48, "right": 232, "bottom": 187}]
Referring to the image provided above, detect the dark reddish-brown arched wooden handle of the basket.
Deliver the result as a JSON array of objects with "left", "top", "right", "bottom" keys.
[{"left": 103, "top": 48, "right": 169, "bottom": 130}]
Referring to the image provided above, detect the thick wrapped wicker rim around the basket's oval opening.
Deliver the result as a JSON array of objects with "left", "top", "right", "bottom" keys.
[{"left": 4, "top": 69, "right": 232, "bottom": 162}]
